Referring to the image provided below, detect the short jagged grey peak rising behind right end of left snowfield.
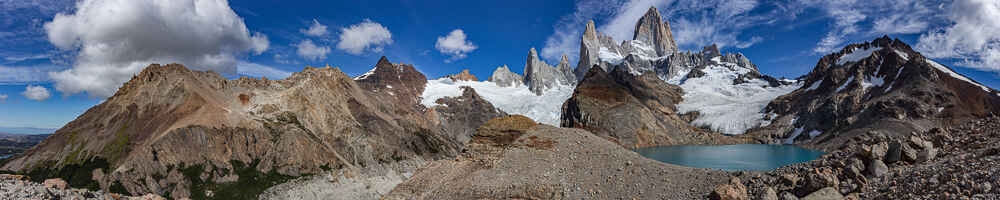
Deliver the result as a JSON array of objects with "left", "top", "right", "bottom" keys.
[{"left": 524, "top": 48, "right": 571, "bottom": 95}]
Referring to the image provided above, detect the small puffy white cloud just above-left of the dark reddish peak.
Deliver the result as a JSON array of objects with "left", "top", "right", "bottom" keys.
[{"left": 337, "top": 19, "right": 392, "bottom": 55}]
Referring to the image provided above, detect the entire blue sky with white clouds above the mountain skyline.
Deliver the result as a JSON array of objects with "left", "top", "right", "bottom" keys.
[{"left": 0, "top": 0, "right": 1000, "bottom": 132}]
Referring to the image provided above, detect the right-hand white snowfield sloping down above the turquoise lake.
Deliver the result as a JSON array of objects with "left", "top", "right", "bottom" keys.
[{"left": 677, "top": 60, "right": 802, "bottom": 135}]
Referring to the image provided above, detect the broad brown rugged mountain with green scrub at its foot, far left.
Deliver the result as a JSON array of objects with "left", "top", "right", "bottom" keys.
[{"left": 2, "top": 57, "right": 496, "bottom": 198}]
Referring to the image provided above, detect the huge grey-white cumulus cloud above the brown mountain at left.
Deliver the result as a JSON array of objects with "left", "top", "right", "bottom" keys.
[{"left": 44, "top": 0, "right": 270, "bottom": 97}]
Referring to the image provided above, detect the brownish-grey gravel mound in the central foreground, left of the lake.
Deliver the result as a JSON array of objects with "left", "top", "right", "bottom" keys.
[{"left": 383, "top": 116, "right": 728, "bottom": 199}]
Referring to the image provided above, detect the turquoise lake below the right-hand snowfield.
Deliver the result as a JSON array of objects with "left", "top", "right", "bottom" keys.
[{"left": 635, "top": 144, "right": 824, "bottom": 171}]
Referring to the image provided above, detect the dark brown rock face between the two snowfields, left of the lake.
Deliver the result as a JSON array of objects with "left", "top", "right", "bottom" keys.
[{"left": 561, "top": 65, "right": 747, "bottom": 148}]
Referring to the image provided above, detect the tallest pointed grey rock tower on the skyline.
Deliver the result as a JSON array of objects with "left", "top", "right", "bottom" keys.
[{"left": 632, "top": 7, "right": 677, "bottom": 56}]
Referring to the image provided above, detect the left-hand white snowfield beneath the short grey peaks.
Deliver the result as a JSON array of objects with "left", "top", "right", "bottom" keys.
[{"left": 420, "top": 78, "right": 574, "bottom": 126}]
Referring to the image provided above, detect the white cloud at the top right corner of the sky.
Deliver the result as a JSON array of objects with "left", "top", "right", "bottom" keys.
[{"left": 916, "top": 0, "right": 1000, "bottom": 71}]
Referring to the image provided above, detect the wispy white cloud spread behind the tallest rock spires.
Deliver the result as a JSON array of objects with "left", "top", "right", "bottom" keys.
[{"left": 541, "top": 0, "right": 764, "bottom": 60}]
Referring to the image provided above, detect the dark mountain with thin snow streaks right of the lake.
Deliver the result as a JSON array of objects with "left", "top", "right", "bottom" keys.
[{"left": 754, "top": 36, "right": 1000, "bottom": 150}]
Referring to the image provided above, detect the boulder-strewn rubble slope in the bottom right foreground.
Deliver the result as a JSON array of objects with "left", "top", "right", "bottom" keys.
[{"left": 712, "top": 116, "right": 1000, "bottom": 199}]
